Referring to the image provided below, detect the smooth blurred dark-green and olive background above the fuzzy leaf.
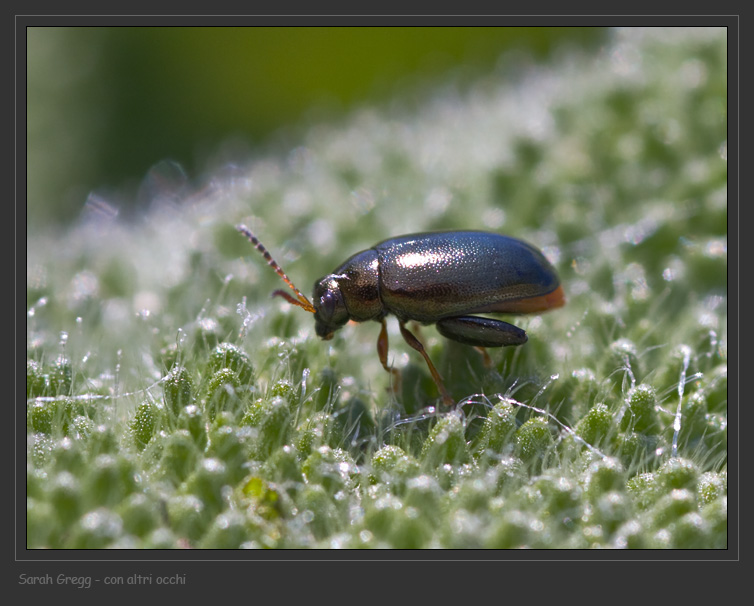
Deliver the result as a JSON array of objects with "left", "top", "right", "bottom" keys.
[{"left": 27, "top": 27, "right": 606, "bottom": 230}]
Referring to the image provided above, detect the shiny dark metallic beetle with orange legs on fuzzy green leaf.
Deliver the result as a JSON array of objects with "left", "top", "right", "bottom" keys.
[{"left": 237, "top": 225, "right": 565, "bottom": 405}]
